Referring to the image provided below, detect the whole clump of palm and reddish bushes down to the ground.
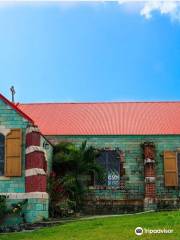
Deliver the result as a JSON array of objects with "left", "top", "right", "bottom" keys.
[{"left": 49, "top": 141, "right": 102, "bottom": 216}]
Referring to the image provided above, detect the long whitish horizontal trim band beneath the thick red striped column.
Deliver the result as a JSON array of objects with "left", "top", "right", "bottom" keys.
[{"left": 0, "top": 192, "right": 49, "bottom": 199}]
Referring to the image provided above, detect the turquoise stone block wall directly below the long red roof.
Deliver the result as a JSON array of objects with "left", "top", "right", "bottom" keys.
[{"left": 48, "top": 135, "right": 180, "bottom": 200}]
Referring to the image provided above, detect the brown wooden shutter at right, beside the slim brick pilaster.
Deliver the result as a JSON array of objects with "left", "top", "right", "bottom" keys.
[{"left": 164, "top": 151, "right": 178, "bottom": 187}]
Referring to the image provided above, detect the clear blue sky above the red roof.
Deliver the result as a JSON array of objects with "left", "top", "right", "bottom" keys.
[{"left": 0, "top": 2, "right": 180, "bottom": 102}]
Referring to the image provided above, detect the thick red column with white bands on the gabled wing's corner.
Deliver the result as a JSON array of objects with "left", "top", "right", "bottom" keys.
[{"left": 25, "top": 126, "right": 47, "bottom": 193}]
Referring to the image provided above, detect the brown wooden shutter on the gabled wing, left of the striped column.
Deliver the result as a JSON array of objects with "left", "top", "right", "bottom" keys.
[{"left": 5, "top": 129, "right": 22, "bottom": 177}]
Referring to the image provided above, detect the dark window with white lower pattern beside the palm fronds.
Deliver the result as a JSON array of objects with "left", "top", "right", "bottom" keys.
[{"left": 95, "top": 150, "right": 120, "bottom": 187}]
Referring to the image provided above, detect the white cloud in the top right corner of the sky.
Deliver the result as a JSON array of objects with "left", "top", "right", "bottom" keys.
[{"left": 119, "top": 0, "right": 180, "bottom": 22}]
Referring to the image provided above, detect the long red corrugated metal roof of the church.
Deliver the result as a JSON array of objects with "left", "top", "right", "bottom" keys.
[{"left": 19, "top": 102, "right": 180, "bottom": 135}]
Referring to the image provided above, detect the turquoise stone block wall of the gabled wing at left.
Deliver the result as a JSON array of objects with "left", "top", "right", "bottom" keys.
[{"left": 0, "top": 100, "right": 49, "bottom": 225}]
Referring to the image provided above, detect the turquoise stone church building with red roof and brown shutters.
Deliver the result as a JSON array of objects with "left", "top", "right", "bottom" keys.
[{"left": 0, "top": 95, "right": 180, "bottom": 222}]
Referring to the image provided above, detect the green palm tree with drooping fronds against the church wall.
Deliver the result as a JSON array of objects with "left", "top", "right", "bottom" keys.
[{"left": 53, "top": 141, "right": 102, "bottom": 211}]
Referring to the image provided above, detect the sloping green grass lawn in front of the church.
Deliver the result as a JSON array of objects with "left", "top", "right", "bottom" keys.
[{"left": 0, "top": 211, "right": 180, "bottom": 240}]
